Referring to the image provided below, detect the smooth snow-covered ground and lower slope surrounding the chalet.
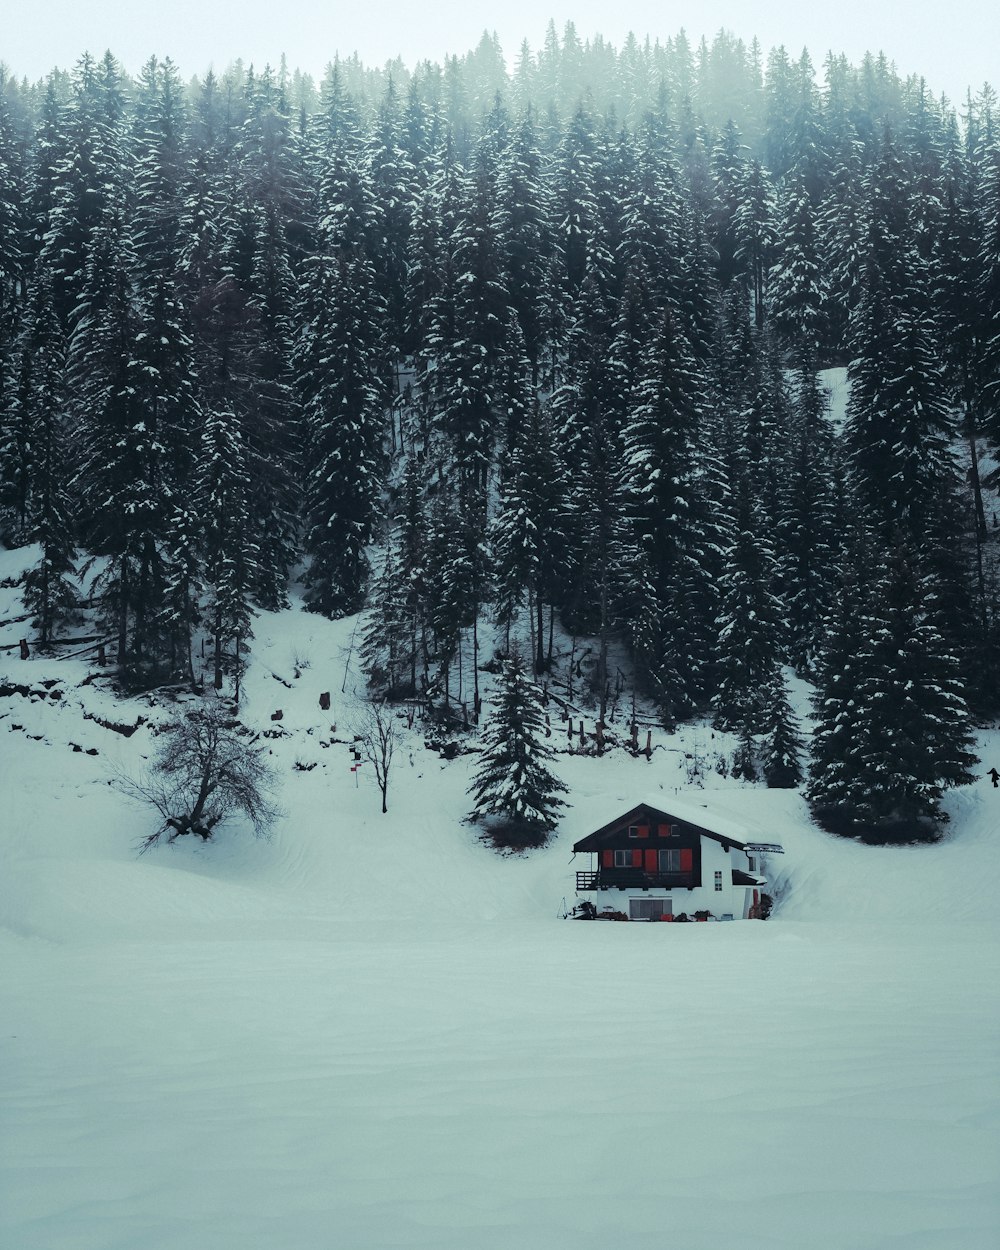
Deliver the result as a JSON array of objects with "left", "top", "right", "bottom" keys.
[{"left": 0, "top": 555, "right": 1000, "bottom": 1250}]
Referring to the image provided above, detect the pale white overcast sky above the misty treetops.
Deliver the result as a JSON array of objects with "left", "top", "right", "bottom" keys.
[{"left": 0, "top": 0, "right": 1000, "bottom": 101}]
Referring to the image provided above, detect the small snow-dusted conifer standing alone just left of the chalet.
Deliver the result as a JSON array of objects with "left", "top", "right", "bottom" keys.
[{"left": 469, "top": 651, "right": 566, "bottom": 846}]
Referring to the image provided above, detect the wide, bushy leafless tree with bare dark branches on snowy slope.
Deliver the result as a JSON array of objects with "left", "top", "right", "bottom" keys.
[{"left": 114, "top": 699, "right": 281, "bottom": 851}]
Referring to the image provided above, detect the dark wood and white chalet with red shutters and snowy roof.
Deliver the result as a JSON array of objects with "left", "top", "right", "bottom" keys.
[{"left": 573, "top": 803, "right": 781, "bottom": 920}]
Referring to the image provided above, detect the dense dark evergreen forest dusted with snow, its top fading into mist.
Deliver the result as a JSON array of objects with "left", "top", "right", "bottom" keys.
[{"left": 0, "top": 24, "right": 1000, "bottom": 829}]
